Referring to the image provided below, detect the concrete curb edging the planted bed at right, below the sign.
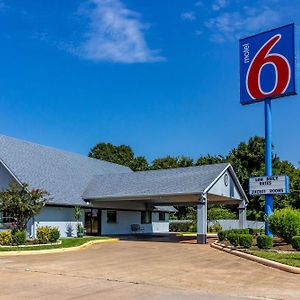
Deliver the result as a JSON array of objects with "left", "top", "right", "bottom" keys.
[{"left": 210, "top": 241, "right": 300, "bottom": 274}]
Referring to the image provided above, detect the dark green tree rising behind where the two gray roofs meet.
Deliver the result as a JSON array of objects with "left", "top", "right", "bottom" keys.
[{"left": 89, "top": 143, "right": 148, "bottom": 171}]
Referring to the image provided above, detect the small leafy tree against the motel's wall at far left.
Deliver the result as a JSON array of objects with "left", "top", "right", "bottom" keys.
[{"left": 0, "top": 183, "right": 48, "bottom": 231}]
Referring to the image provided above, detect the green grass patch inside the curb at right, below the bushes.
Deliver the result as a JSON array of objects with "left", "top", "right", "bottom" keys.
[{"left": 247, "top": 250, "right": 300, "bottom": 267}]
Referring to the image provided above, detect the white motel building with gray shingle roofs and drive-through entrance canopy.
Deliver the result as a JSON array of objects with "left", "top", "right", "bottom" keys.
[{"left": 0, "top": 135, "right": 248, "bottom": 244}]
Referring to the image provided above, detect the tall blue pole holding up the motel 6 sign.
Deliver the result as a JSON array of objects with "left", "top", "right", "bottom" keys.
[{"left": 265, "top": 99, "right": 273, "bottom": 236}]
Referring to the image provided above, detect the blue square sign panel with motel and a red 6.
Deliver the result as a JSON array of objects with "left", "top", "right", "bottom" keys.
[{"left": 240, "top": 24, "right": 296, "bottom": 104}]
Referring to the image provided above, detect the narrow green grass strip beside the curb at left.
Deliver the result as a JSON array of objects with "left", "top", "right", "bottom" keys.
[{"left": 0, "top": 236, "right": 109, "bottom": 251}]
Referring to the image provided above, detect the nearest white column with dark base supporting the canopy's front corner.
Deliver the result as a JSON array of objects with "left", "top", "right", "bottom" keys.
[{"left": 197, "top": 194, "right": 207, "bottom": 244}]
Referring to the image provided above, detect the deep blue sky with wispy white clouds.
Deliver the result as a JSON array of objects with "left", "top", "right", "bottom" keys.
[{"left": 0, "top": 0, "right": 300, "bottom": 166}]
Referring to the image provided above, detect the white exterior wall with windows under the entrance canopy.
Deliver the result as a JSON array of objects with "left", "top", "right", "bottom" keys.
[{"left": 101, "top": 210, "right": 169, "bottom": 235}]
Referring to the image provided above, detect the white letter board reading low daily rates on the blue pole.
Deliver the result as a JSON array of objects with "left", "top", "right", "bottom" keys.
[{"left": 249, "top": 175, "right": 289, "bottom": 196}]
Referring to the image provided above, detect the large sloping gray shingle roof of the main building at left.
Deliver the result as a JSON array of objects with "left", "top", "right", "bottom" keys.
[{"left": 0, "top": 135, "right": 132, "bottom": 205}]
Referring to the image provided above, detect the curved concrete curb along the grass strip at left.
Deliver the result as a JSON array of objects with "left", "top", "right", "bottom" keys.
[{"left": 0, "top": 238, "right": 119, "bottom": 257}]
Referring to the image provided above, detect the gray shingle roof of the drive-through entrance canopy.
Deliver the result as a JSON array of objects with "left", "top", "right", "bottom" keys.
[{"left": 83, "top": 163, "right": 229, "bottom": 200}]
